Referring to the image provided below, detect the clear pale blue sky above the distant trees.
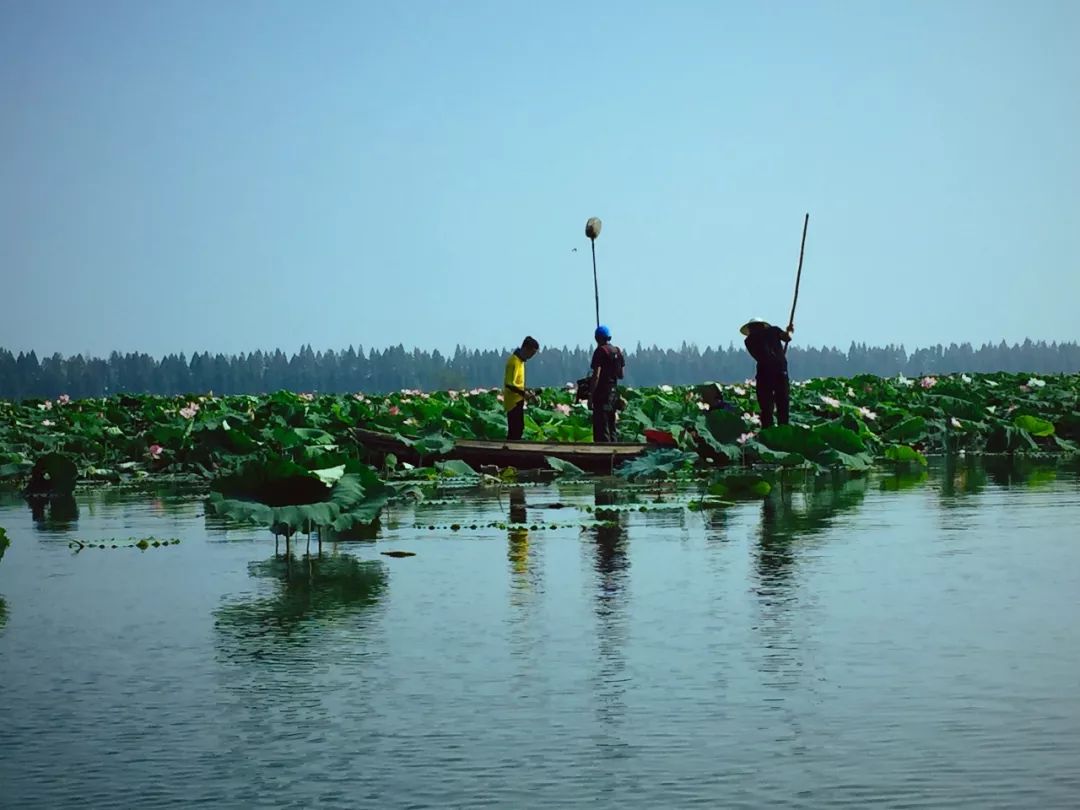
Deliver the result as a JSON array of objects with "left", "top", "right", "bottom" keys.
[{"left": 0, "top": 0, "right": 1080, "bottom": 354}]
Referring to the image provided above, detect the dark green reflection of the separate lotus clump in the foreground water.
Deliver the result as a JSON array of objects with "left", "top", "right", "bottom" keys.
[{"left": 214, "top": 553, "right": 388, "bottom": 658}]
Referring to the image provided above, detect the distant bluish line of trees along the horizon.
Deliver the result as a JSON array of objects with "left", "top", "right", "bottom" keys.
[{"left": 0, "top": 339, "right": 1080, "bottom": 400}]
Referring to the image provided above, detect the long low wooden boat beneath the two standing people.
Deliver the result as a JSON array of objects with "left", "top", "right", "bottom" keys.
[{"left": 353, "top": 428, "right": 649, "bottom": 473}]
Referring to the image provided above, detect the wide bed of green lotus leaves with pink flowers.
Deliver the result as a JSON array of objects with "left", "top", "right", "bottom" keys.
[{"left": 0, "top": 374, "right": 1080, "bottom": 540}]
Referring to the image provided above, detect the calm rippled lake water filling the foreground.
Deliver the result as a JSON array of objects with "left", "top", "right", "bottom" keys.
[{"left": 0, "top": 461, "right": 1080, "bottom": 808}]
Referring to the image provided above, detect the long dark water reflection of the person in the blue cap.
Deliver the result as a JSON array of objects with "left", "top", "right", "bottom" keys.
[{"left": 586, "top": 482, "right": 630, "bottom": 753}]
